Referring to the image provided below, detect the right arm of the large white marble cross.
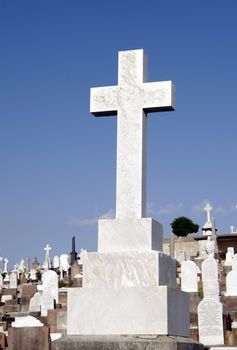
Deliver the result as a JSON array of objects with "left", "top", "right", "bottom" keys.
[{"left": 143, "top": 81, "right": 175, "bottom": 112}]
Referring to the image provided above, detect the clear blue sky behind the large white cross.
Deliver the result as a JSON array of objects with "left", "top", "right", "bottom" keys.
[{"left": 0, "top": 0, "right": 237, "bottom": 264}]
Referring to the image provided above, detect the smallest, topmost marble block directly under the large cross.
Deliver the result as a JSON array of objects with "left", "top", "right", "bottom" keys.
[{"left": 98, "top": 218, "right": 163, "bottom": 253}]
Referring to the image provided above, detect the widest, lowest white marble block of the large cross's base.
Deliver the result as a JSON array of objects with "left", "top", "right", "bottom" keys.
[{"left": 67, "top": 286, "right": 189, "bottom": 336}]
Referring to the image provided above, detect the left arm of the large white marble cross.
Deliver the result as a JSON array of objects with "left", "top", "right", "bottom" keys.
[{"left": 90, "top": 86, "right": 118, "bottom": 116}]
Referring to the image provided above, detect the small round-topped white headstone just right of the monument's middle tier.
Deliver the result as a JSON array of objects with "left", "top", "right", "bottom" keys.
[{"left": 181, "top": 260, "right": 198, "bottom": 293}]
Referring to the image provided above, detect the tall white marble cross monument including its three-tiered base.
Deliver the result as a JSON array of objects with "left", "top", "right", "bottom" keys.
[{"left": 67, "top": 50, "right": 189, "bottom": 336}]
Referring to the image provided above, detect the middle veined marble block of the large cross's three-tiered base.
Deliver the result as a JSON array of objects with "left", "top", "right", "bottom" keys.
[{"left": 81, "top": 251, "right": 176, "bottom": 288}]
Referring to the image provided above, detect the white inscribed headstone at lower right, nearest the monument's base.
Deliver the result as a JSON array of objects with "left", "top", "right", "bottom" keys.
[{"left": 198, "top": 298, "right": 224, "bottom": 346}]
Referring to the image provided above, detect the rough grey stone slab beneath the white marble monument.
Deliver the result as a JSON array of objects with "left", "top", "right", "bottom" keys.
[{"left": 51, "top": 335, "right": 204, "bottom": 350}]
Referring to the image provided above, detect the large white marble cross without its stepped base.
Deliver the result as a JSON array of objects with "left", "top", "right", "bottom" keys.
[{"left": 90, "top": 50, "right": 175, "bottom": 219}]
